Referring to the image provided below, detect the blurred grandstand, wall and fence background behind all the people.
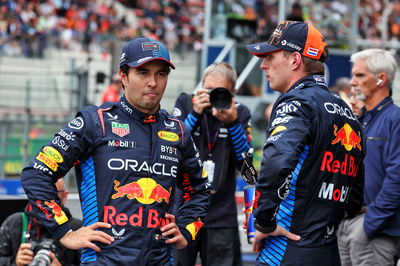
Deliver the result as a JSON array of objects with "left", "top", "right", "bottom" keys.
[{"left": 0, "top": 0, "right": 400, "bottom": 262}]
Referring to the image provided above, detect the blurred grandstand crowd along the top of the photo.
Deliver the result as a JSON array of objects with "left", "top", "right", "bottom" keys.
[{"left": 0, "top": 0, "right": 400, "bottom": 57}]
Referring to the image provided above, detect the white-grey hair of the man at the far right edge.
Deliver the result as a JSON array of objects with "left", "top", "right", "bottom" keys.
[{"left": 350, "top": 48, "right": 397, "bottom": 91}]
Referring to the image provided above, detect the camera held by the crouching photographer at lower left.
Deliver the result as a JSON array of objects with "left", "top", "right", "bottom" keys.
[{"left": 29, "top": 238, "right": 56, "bottom": 266}]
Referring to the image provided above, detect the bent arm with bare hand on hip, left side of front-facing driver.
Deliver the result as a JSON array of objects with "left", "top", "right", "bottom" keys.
[{"left": 21, "top": 109, "right": 114, "bottom": 251}]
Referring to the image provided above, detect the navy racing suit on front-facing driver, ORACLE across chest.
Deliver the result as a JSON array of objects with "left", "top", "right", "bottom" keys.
[{"left": 21, "top": 97, "right": 210, "bottom": 265}]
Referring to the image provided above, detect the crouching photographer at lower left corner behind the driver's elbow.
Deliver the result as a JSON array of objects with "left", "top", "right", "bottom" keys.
[{"left": 0, "top": 179, "right": 81, "bottom": 266}]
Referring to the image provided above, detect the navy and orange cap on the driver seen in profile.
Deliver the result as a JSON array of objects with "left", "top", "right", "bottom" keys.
[{"left": 246, "top": 21, "right": 327, "bottom": 61}]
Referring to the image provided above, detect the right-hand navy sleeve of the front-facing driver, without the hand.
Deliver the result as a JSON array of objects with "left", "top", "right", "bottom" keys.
[{"left": 177, "top": 121, "right": 210, "bottom": 243}]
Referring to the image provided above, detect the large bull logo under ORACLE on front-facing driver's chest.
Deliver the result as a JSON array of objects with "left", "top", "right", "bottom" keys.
[{"left": 111, "top": 178, "right": 172, "bottom": 204}]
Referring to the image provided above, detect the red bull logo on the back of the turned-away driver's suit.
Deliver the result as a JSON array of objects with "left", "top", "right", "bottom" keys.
[{"left": 331, "top": 123, "right": 361, "bottom": 151}]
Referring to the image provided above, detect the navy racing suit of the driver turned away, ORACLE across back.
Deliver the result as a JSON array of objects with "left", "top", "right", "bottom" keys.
[{"left": 254, "top": 75, "right": 365, "bottom": 265}]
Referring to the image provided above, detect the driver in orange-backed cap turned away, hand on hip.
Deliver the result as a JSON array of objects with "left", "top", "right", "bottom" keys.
[{"left": 245, "top": 21, "right": 365, "bottom": 265}]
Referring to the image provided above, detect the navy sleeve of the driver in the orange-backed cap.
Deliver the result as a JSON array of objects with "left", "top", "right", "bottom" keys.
[{"left": 254, "top": 95, "right": 314, "bottom": 233}]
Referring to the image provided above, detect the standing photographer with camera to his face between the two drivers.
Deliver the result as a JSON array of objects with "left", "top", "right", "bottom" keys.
[{"left": 173, "top": 62, "right": 251, "bottom": 265}]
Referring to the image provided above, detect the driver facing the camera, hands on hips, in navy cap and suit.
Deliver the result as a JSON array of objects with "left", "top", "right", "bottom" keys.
[{"left": 21, "top": 37, "right": 210, "bottom": 265}]
